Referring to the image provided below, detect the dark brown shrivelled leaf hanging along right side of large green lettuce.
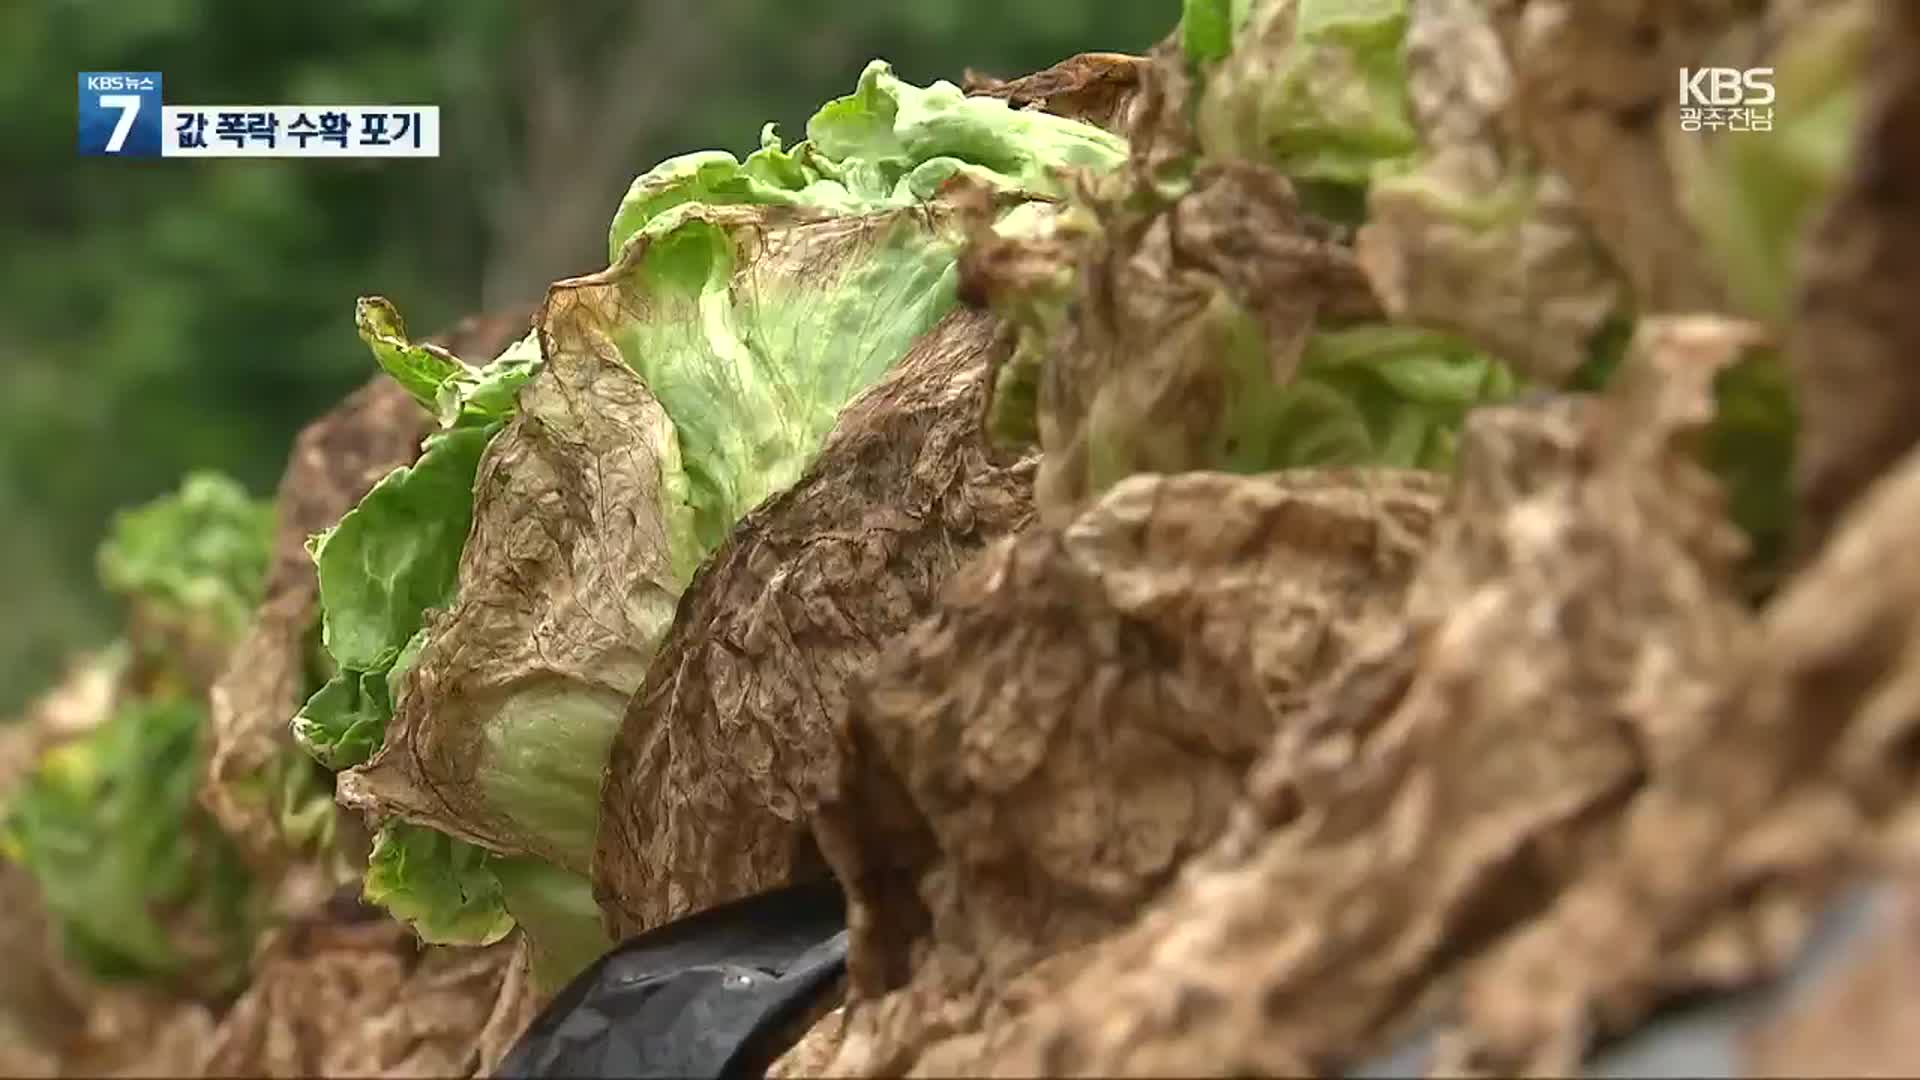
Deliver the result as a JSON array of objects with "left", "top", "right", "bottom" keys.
[{"left": 593, "top": 311, "right": 1033, "bottom": 936}]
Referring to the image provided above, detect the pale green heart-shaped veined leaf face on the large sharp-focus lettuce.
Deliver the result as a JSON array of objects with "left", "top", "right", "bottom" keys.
[{"left": 614, "top": 206, "right": 958, "bottom": 552}]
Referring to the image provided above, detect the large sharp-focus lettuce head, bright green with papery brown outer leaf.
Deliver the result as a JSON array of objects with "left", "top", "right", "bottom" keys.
[{"left": 296, "top": 61, "right": 1125, "bottom": 984}]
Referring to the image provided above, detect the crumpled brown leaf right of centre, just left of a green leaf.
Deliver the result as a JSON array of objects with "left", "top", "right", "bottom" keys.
[{"left": 960, "top": 163, "right": 1379, "bottom": 525}]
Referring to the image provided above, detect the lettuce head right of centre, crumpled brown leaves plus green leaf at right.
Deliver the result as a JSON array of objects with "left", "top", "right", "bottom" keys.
[{"left": 968, "top": 155, "right": 1517, "bottom": 521}]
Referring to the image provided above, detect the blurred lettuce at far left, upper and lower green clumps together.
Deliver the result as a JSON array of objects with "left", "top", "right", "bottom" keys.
[{"left": 0, "top": 473, "right": 273, "bottom": 995}]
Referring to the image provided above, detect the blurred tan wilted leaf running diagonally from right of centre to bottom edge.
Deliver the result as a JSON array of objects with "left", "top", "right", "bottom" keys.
[{"left": 883, "top": 321, "right": 1751, "bottom": 1074}]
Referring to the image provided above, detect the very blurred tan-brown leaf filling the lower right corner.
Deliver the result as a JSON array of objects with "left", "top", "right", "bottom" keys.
[{"left": 1461, "top": 413, "right": 1920, "bottom": 1070}]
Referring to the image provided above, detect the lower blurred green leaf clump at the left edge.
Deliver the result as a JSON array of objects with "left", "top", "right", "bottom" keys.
[{"left": 0, "top": 700, "right": 259, "bottom": 994}]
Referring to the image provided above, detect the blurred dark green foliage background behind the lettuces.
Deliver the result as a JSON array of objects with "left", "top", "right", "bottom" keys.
[{"left": 0, "top": 0, "right": 1179, "bottom": 715}]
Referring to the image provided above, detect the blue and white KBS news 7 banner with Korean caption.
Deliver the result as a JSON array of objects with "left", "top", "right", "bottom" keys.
[{"left": 77, "top": 71, "right": 440, "bottom": 158}]
